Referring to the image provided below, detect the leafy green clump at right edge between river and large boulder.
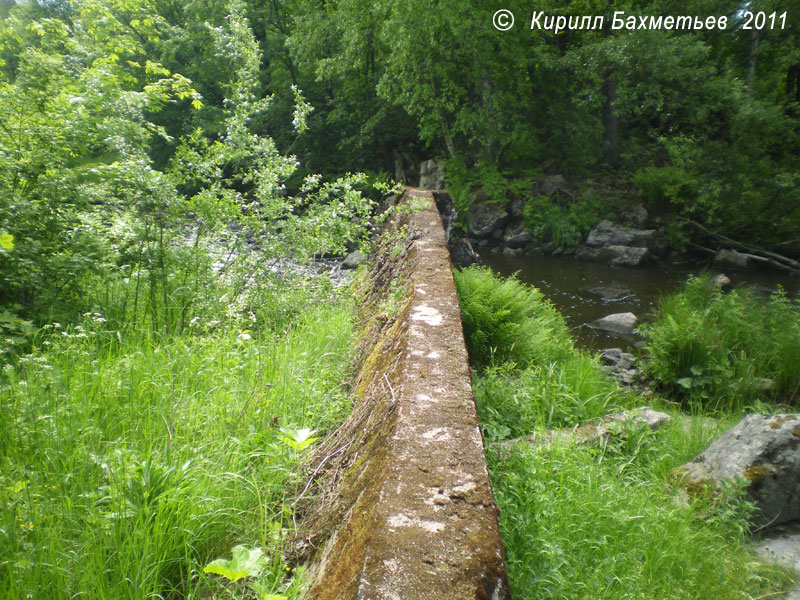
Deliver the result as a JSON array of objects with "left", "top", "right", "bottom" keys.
[{"left": 645, "top": 275, "right": 800, "bottom": 408}]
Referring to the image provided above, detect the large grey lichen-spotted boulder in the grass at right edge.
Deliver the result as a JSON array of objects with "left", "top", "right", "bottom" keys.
[{"left": 674, "top": 414, "right": 800, "bottom": 527}]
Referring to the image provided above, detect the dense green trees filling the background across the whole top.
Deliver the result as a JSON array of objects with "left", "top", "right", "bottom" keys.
[{"left": 0, "top": 0, "right": 800, "bottom": 329}]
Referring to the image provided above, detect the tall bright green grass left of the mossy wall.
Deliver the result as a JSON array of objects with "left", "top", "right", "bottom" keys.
[{"left": 0, "top": 290, "right": 353, "bottom": 599}]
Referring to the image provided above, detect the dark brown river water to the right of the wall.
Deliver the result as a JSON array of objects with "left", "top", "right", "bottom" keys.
[{"left": 481, "top": 252, "right": 800, "bottom": 349}]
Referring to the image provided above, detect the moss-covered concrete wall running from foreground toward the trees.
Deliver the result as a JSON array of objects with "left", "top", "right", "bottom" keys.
[{"left": 295, "top": 189, "right": 510, "bottom": 600}]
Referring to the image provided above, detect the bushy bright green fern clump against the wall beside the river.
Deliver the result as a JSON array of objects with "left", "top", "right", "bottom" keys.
[{"left": 455, "top": 266, "right": 572, "bottom": 371}]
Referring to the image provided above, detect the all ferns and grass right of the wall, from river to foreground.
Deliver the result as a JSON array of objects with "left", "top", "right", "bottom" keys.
[{"left": 456, "top": 268, "right": 792, "bottom": 600}]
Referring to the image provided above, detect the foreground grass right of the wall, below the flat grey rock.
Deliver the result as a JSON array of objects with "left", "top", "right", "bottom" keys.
[{"left": 489, "top": 434, "right": 792, "bottom": 600}]
